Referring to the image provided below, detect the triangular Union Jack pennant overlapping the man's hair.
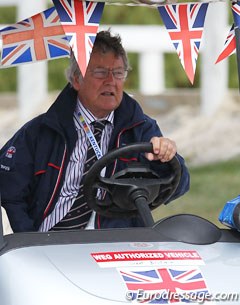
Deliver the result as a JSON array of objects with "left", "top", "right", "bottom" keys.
[{"left": 53, "top": 0, "right": 104, "bottom": 75}]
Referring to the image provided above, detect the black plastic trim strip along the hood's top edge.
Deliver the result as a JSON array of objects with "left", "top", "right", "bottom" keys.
[{"left": 0, "top": 221, "right": 240, "bottom": 255}]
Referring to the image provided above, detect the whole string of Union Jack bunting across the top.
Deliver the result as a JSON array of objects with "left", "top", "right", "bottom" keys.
[{"left": 0, "top": 0, "right": 240, "bottom": 84}]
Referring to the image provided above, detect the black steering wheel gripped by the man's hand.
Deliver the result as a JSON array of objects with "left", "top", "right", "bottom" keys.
[{"left": 83, "top": 143, "right": 181, "bottom": 221}]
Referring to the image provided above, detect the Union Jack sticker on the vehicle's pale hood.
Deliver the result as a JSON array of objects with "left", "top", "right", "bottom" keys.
[{"left": 119, "top": 267, "right": 209, "bottom": 304}]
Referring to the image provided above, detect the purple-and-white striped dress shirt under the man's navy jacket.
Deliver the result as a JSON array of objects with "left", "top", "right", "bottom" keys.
[{"left": 39, "top": 100, "right": 114, "bottom": 232}]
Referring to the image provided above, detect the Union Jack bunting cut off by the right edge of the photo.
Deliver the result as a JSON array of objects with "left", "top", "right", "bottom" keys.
[{"left": 215, "top": 1, "right": 240, "bottom": 64}]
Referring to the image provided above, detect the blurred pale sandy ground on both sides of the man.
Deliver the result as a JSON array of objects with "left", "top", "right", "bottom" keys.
[{"left": 0, "top": 90, "right": 240, "bottom": 165}]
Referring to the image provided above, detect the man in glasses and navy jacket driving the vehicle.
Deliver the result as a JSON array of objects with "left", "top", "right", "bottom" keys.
[{"left": 0, "top": 31, "right": 189, "bottom": 232}]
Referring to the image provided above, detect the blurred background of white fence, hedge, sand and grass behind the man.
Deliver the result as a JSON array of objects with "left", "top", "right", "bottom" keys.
[{"left": 0, "top": 0, "right": 240, "bottom": 226}]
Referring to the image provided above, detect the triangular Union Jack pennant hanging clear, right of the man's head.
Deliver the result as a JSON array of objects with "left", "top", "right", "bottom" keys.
[{"left": 158, "top": 3, "right": 208, "bottom": 83}]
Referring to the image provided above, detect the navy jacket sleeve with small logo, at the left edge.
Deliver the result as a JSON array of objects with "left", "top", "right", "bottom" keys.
[{"left": 0, "top": 126, "right": 35, "bottom": 232}]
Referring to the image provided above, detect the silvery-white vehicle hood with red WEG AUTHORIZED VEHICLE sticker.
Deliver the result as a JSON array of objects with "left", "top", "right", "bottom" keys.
[{"left": 0, "top": 242, "right": 240, "bottom": 305}]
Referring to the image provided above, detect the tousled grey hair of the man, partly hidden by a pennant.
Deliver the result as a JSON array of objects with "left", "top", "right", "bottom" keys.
[{"left": 66, "top": 29, "right": 130, "bottom": 84}]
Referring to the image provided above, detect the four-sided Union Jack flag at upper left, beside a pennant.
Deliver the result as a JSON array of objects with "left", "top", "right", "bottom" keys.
[{"left": 0, "top": 7, "right": 70, "bottom": 67}]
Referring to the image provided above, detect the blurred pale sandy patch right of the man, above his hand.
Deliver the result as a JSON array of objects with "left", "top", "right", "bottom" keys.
[{"left": 158, "top": 97, "right": 240, "bottom": 165}]
